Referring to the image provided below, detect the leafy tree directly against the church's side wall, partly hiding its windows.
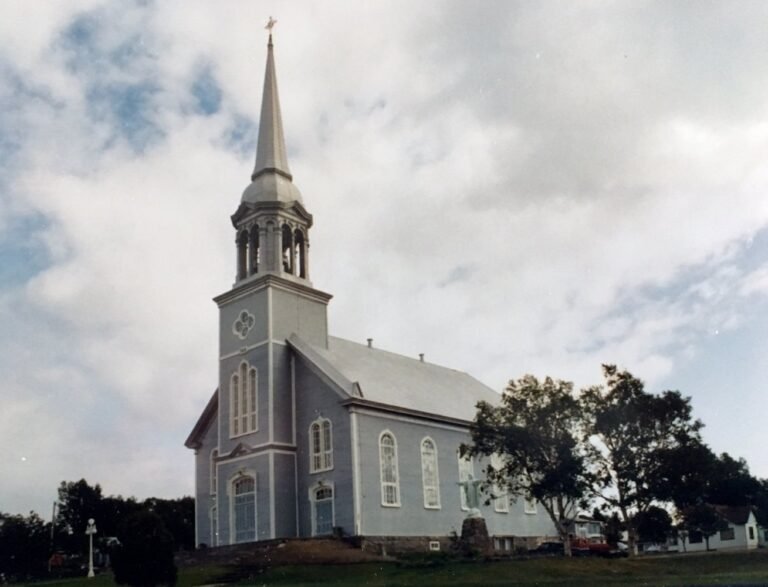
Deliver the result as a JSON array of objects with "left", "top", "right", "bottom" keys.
[{"left": 462, "top": 375, "right": 589, "bottom": 555}]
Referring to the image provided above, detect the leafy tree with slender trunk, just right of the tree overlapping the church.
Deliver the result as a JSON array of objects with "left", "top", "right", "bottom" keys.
[{"left": 581, "top": 365, "right": 702, "bottom": 556}]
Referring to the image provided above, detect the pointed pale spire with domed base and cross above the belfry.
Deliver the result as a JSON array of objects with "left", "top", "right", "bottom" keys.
[{"left": 243, "top": 17, "right": 301, "bottom": 203}]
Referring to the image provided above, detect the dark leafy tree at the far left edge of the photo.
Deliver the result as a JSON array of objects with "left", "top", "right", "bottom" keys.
[{"left": 0, "top": 512, "right": 50, "bottom": 580}]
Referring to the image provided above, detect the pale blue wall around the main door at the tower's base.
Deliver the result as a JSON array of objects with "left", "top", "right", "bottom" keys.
[{"left": 217, "top": 453, "right": 272, "bottom": 545}]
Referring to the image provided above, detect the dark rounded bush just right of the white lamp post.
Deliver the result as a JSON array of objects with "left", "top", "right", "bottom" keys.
[{"left": 112, "top": 510, "right": 177, "bottom": 587}]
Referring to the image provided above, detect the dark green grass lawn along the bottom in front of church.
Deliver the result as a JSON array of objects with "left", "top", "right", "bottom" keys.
[{"left": 16, "top": 550, "right": 768, "bottom": 587}]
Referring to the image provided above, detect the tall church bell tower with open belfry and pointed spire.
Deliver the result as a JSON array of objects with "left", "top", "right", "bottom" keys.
[{"left": 214, "top": 27, "right": 331, "bottom": 544}]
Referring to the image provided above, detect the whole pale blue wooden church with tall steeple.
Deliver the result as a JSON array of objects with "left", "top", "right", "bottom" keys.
[{"left": 185, "top": 35, "right": 556, "bottom": 550}]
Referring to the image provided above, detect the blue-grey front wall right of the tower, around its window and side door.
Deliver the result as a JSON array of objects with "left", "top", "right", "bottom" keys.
[{"left": 295, "top": 359, "right": 355, "bottom": 536}]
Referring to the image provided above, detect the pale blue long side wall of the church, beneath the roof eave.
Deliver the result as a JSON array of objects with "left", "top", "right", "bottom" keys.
[{"left": 357, "top": 412, "right": 554, "bottom": 536}]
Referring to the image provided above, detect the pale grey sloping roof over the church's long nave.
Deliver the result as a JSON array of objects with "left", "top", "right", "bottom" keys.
[{"left": 288, "top": 335, "right": 500, "bottom": 422}]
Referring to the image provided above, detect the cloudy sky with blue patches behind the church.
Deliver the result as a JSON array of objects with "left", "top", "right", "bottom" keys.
[{"left": 0, "top": 0, "right": 768, "bottom": 515}]
